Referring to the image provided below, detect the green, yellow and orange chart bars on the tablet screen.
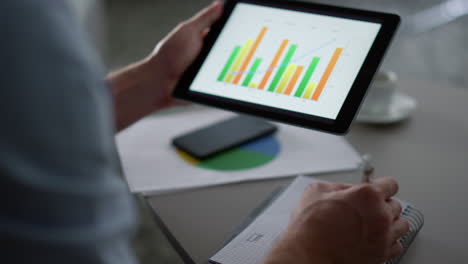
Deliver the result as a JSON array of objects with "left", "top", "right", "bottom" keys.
[{"left": 217, "top": 27, "right": 343, "bottom": 101}]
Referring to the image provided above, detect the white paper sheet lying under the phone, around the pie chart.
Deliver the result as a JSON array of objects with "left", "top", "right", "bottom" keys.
[{"left": 117, "top": 109, "right": 361, "bottom": 195}]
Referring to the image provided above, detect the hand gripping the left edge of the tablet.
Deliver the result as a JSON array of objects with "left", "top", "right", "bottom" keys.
[{"left": 108, "top": 1, "right": 223, "bottom": 130}]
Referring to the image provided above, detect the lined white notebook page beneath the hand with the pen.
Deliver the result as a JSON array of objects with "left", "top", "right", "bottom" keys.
[{"left": 210, "top": 176, "right": 416, "bottom": 264}]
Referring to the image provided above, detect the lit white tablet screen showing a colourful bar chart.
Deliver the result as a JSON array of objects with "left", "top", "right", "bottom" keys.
[{"left": 189, "top": 3, "right": 381, "bottom": 120}]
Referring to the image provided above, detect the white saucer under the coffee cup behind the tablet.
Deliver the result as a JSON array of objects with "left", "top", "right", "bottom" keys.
[{"left": 356, "top": 92, "right": 417, "bottom": 124}]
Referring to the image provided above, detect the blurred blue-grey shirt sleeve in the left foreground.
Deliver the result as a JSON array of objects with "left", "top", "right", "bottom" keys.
[{"left": 0, "top": 0, "right": 135, "bottom": 264}]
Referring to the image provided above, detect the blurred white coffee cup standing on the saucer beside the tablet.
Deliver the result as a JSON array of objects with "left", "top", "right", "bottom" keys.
[{"left": 361, "top": 70, "right": 398, "bottom": 115}]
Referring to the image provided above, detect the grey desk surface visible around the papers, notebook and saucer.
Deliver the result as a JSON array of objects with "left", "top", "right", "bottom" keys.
[{"left": 148, "top": 81, "right": 468, "bottom": 264}]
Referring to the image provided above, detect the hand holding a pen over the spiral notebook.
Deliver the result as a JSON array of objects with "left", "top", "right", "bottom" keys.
[{"left": 266, "top": 178, "right": 409, "bottom": 264}]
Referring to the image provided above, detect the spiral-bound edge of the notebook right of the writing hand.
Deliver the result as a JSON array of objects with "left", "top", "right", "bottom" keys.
[{"left": 385, "top": 205, "right": 424, "bottom": 264}]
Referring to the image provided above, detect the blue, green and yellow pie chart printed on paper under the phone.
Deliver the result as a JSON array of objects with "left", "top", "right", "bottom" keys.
[{"left": 177, "top": 136, "right": 280, "bottom": 171}]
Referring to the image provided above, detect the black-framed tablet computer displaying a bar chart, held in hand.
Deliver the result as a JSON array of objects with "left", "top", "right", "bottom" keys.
[{"left": 174, "top": 0, "right": 400, "bottom": 134}]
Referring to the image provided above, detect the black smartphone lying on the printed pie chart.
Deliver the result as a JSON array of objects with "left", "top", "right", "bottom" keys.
[{"left": 172, "top": 116, "right": 277, "bottom": 160}]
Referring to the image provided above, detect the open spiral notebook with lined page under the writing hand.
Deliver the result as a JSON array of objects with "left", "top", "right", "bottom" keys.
[{"left": 210, "top": 176, "right": 424, "bottom": 264}]
